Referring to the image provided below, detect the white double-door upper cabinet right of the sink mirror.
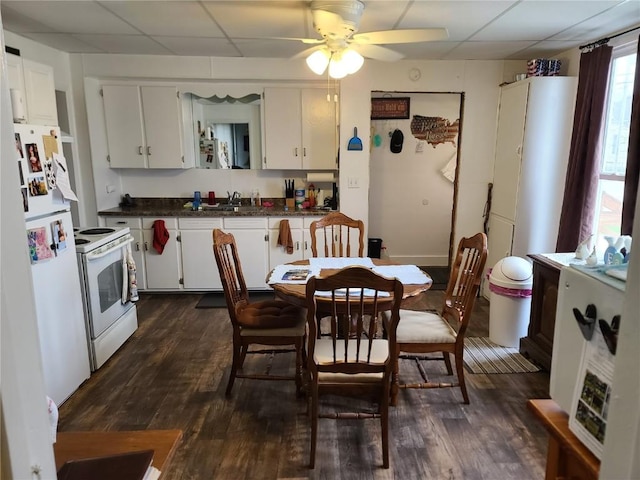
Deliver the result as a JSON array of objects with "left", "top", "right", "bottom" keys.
[{"left": 264, "top": 88, "right": 337, "bottom": 170}]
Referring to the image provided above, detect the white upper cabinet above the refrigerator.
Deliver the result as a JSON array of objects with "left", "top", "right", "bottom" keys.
[{"left": 6, "top": 54, "right": 58, "bottom": 126}]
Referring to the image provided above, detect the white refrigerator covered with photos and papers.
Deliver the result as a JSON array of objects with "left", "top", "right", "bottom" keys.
[{"left": 14, "top": 124, "right": 90, "bottom": 404}]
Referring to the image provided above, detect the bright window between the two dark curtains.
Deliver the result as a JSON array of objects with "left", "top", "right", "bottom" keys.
[{"left": 594, "top": 43, "right": 637, "bottom": 251}]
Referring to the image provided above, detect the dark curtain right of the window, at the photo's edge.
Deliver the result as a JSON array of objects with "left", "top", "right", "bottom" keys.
[{"left": 621, "top": 37, "right": 640, "bottom": 235}]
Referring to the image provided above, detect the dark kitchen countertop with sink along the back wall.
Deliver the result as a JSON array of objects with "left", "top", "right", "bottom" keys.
[{"left": 98, "top": 198, "right": 331, "bottom": 217}]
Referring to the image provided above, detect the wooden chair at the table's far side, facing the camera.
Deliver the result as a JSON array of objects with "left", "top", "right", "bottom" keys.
[{"left": 310, "top": 212, "right": 364, "bottom": 257}]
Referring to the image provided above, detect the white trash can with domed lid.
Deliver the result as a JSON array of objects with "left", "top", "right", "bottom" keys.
[{"left": 489, "top": 257, "right": 533, "bottom": 348}]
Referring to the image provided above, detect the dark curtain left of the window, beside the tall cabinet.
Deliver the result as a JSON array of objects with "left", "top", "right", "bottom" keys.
[{"left": 556, "top": 45, "right": 613, "bottom": 252}]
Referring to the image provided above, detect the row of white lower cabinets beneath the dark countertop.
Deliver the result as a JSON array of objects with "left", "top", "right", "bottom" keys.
[{"left": 101, "top": 216, "right": 322, "bottom": 291}]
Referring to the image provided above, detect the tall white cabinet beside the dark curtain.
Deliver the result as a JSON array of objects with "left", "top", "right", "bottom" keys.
[{"left": 484, "top": 77, "right": 578, "bottom": 295}]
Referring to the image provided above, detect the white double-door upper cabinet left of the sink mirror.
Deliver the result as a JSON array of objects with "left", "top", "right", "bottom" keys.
[{"left": 102, "top": 85, "right": 185, "bottom": 168}]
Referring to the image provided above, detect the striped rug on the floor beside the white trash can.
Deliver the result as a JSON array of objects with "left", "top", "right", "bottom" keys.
[{"left": 464, "top": 337, "right": 540, "bottom": 373}]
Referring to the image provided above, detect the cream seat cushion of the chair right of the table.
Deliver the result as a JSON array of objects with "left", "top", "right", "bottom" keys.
[{"left": 396, "top": 310, "right": 456, "bottom": 343}]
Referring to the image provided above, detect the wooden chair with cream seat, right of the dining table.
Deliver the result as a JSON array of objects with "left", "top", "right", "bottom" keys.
[{"left": 391, "top": 233, "right": 487, "bottom": 405}]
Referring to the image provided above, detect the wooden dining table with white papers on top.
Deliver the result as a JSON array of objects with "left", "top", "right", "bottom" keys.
[{"left": 267, "top": 257, "right": 433, "bottom": 311}]
